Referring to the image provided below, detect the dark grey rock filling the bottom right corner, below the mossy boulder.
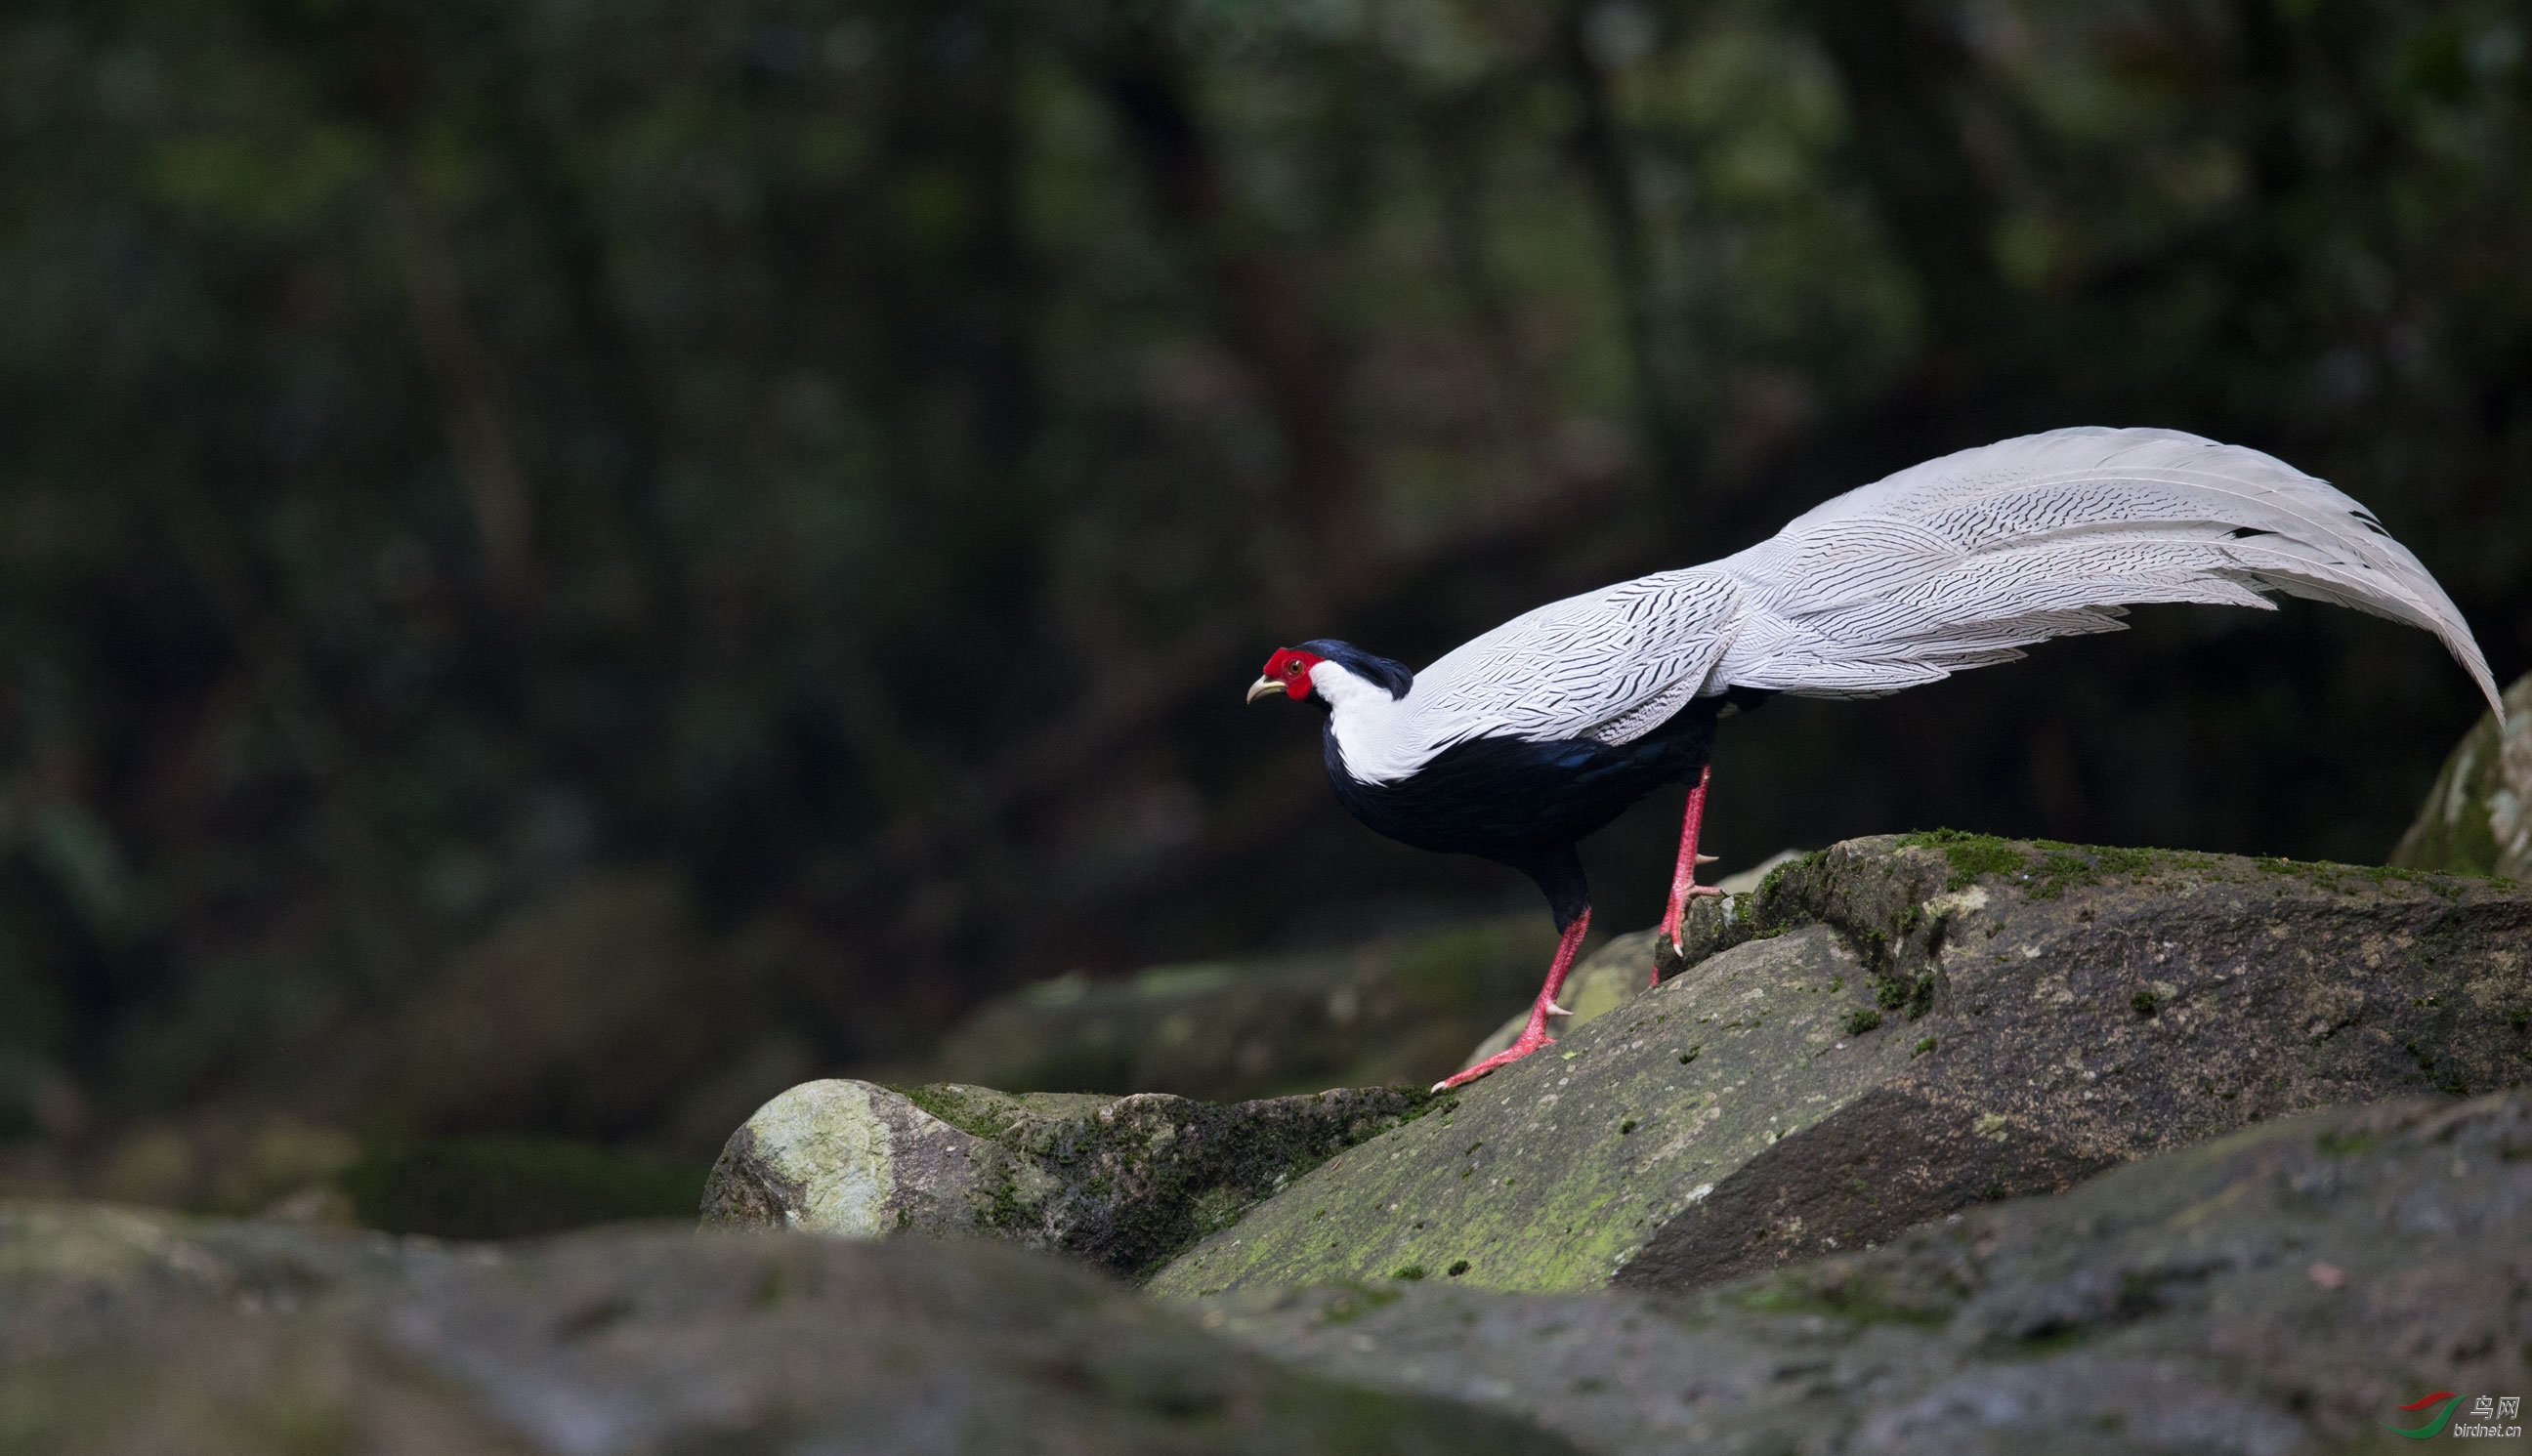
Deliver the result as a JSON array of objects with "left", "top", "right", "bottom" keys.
[{"left": 1205, "top": 1094, "right": 2532, "bottom": 1456}]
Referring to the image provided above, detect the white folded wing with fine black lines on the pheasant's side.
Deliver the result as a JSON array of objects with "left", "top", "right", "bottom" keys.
[{"left": 1400, "top": 567, "right": 1740, "bottom": 757}]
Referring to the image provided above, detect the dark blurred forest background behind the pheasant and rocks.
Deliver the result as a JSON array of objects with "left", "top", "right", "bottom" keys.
[{"left": 0, "top": 0, "right": 2532, "bottom": 1205}]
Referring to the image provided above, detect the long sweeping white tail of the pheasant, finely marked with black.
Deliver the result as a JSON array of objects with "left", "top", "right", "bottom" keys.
[{"left": 1709, "top": 428, "right": 2504, "bottom": 717}]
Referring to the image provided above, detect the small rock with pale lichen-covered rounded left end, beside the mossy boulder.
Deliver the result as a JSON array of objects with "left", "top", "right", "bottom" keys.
[{"left": 704, "top": 1081, "right": 1430, "bottom": 1276}]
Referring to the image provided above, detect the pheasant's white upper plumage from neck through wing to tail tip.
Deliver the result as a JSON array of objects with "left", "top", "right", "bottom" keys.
[{"left": 1312, "top": 426, "right": 2504, "bottom": 782}]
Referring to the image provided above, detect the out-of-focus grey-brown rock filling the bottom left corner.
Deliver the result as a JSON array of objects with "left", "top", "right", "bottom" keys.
[{"left": 0, "top": 1205, "right": 1570, "bottom": 1456}]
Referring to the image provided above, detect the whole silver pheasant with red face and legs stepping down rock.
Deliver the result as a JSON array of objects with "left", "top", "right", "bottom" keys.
[{"left": 1248, "top": 426, "right": 2504, "bottom": 1081}]
